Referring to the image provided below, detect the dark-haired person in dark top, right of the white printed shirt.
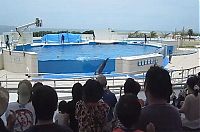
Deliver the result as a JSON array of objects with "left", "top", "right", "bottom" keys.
[{"left": 25, "top": 85, "right": 72, "bottom": 132}]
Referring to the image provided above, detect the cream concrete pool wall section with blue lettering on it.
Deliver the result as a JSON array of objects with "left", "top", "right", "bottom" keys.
[{"left": 115, "top": 54, "right": 163, "bottom": 74}]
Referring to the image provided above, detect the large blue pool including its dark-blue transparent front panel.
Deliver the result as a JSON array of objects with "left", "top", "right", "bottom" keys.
[{"left": 16, "top": 44, "right": 162, "bottom": 73}]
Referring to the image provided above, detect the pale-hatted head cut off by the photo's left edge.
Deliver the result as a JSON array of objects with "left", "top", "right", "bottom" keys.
[{"left": 0, "top": 87, "right": 9, "bottom": 117}]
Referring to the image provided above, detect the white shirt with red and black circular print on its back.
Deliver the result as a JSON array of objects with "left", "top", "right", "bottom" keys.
[{"left": 5, "top": 102, "right": 36, "bottom": 132}]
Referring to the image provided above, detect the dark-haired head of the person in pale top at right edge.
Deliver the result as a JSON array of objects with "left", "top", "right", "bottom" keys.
[{"left": 186, "top": 76, "right": 200, "bottom": 96}]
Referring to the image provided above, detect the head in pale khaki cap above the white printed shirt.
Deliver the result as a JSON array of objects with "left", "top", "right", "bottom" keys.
[{"left": 17, "top": 83, "right": 31, "bottom": 104}]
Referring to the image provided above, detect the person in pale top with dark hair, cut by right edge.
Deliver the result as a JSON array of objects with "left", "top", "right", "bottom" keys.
[{"left": 179, "top": 76, "right": 200, "bottom": 130}]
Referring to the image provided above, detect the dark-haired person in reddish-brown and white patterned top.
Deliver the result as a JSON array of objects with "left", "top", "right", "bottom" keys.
[{"left": 75, "top": 79, "right": 109, "bottom": 132}]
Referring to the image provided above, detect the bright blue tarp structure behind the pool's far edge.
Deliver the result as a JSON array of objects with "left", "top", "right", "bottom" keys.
[{"left": 42, "top": 33, "right": 82, "bottom": 43}]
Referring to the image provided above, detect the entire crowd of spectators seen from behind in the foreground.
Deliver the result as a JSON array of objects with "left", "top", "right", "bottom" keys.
[{"left": 0, "top": 66, "right": 200, "bottom": 132}]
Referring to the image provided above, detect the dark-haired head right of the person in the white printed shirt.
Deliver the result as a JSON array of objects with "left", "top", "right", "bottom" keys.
[{"left": 32, "top": 85, "right": 58, "bottom": 121}]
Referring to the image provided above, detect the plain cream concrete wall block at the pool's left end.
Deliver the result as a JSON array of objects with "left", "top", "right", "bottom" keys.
[{"left": 3, "top": 50, "right": 38, "bottom": 73}]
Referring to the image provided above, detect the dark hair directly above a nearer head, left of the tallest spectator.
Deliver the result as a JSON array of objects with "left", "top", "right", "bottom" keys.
[{"left": 124, "top": 78, "right": 141, "bottom": 96}]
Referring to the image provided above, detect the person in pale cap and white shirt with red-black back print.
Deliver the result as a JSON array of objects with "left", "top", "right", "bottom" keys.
[{"left": 5, "top": 80, "right": 35, "bottom": 132}]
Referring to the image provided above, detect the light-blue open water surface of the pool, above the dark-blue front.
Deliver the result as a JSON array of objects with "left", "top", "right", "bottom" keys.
[{"left": 23, "top": 44, "right": 158, "bottom": 61}]
